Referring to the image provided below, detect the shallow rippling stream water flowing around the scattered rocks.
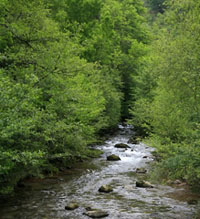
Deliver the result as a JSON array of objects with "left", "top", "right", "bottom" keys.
[{"left": 0, "top": 126, "right": 199, "bottom": 219}]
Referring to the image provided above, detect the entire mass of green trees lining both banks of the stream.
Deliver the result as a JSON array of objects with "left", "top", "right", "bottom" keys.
[{"left": 0, "top": 0, "right": 200, "bottom": 194}]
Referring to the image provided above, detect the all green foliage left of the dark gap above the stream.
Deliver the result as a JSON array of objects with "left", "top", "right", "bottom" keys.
[{"left": 0, "top": 0, "right": 149, "bottom": 194}]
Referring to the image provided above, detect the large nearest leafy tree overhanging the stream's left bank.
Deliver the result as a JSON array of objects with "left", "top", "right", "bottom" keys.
[{"left": 0, "top": 0, "right": 105, "bottom": 193}]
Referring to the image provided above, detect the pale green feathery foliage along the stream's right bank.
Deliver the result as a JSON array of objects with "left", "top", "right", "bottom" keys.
[{"left": 131, "top": 0, "right": 200, "bottom": 185}]
